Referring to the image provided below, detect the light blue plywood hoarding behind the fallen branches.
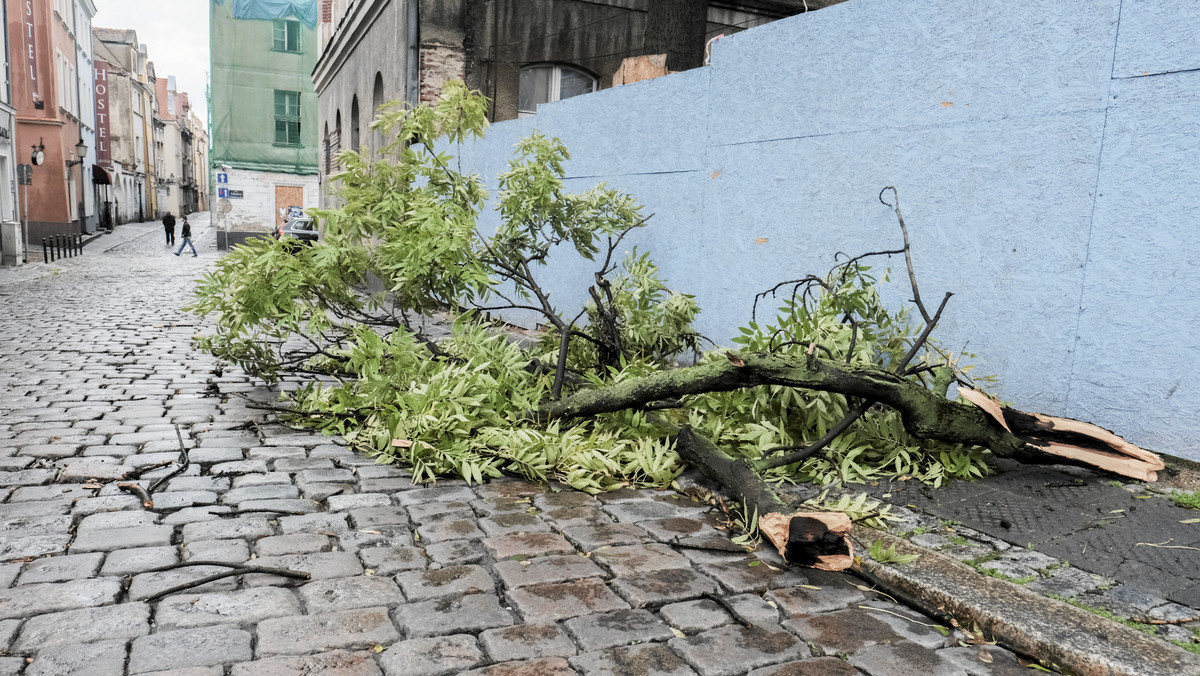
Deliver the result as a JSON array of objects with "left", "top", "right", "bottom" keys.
[{"left": 453, "top": 0, "right": 1200, "bottom": 460}]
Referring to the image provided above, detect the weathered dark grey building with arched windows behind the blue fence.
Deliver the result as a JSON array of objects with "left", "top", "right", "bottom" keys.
[{"left": 313, "top": 0, "right": 838, "bottom": 206}]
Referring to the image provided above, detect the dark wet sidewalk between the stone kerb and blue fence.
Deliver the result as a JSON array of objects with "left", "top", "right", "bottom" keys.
[{"left": 866, "top": 462, "right": 1200, "bottom": 646}]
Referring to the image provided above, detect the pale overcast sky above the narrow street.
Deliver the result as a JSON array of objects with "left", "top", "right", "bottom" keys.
[{"left": 91, "top": 0, "right": 209, "bottom": 120}]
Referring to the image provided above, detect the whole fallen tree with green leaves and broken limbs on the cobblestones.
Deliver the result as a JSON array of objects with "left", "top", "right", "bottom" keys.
[{"left": 192, "top": 84, "right": 1162, "bottom": 566}]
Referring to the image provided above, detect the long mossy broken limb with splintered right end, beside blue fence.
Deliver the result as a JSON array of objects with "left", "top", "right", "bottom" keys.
[{"left": 539, "top": 352, "right": 1163, "bottom": 480}]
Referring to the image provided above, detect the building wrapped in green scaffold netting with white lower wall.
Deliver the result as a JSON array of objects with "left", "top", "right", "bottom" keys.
[{"left": 210, "top": 0, "right": 320, "bottom": 244}]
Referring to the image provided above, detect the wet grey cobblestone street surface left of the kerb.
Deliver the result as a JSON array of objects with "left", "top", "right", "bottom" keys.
[{"left": 0, "top": 223, "right": 1025, "bottom": 676}]
